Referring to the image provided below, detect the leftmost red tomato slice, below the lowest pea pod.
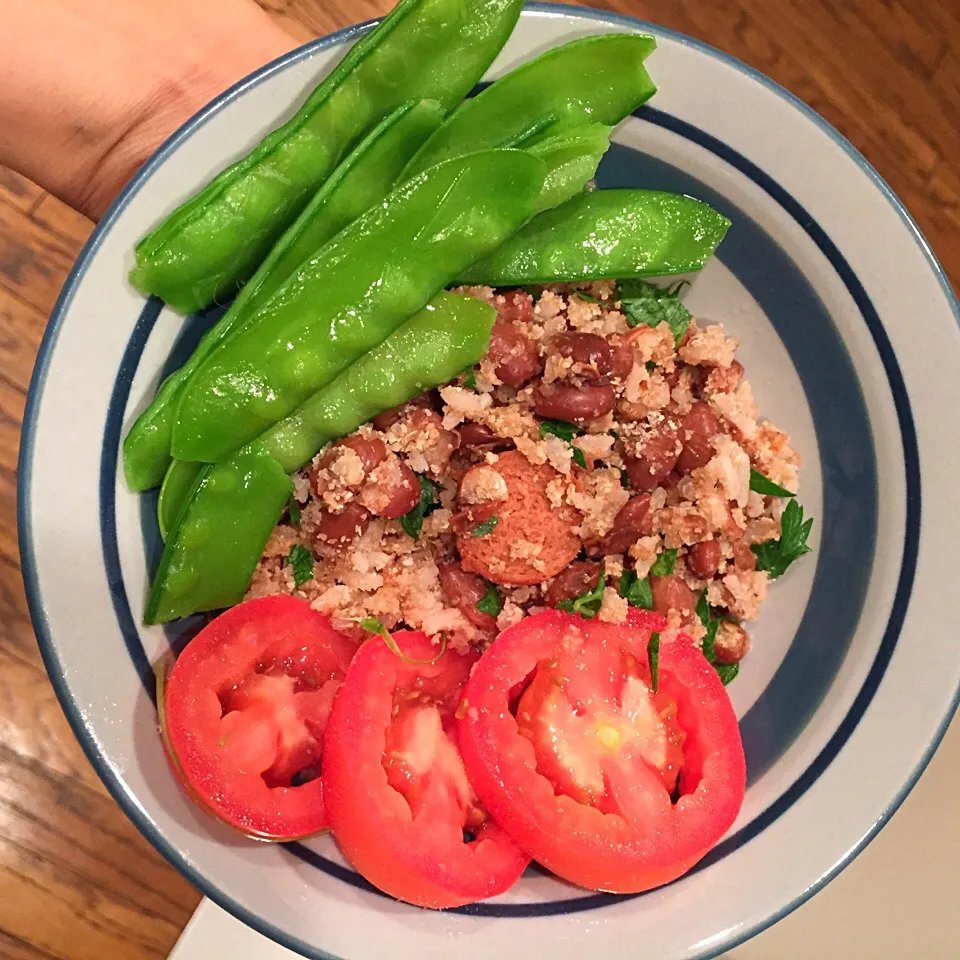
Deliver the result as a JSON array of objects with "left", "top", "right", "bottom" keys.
[{"left": 161, "top": 596, "right": 357, "bottom": 840}]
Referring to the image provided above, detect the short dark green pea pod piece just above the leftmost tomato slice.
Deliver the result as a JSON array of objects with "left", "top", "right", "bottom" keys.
[{"left": 144, "top": 444, "right": 293, "bottom": 623}]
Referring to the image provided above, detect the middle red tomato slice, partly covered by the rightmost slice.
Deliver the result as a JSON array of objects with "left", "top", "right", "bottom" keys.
[{"left": 324, "top": 633, "right": 529, "bottom": 908}]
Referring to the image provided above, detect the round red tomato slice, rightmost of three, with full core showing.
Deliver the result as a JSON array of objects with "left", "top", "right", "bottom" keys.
[{"left": 458, "top": 610, "right": 746, "bottom": 893}]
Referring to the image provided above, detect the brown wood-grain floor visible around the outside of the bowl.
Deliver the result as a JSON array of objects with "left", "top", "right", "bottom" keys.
[{"left": 0, "top": 0, "right": 960, "bottom": 960}]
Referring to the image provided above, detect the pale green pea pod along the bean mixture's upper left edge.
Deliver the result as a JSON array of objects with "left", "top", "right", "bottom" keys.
[{"left": 157, "top": 293, "right": 497, "bottom": 532}]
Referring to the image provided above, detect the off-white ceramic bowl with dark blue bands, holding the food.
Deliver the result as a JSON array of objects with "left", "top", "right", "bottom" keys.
[{"left": 19, "top": 4, "right": 960, "bottom": 960}]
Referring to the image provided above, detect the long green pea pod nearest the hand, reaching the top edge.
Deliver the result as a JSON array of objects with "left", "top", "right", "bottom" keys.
[{"left": 131, "top": 0, "right": 523, "bottom": 313}]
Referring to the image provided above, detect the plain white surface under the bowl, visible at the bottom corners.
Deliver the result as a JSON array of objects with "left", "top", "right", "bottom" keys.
[{"left": 170, "top": 720, "right": 960, "bottom": 960}]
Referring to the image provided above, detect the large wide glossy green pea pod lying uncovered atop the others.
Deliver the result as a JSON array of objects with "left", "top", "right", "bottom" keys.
[{"left": 172, "top": 150, "right": 546, "bottom": 462}]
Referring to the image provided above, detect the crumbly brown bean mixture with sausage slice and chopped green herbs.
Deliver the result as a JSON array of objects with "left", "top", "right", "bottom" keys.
[{"left": 248, "top": 281, "right": 799, "bottom": 664}]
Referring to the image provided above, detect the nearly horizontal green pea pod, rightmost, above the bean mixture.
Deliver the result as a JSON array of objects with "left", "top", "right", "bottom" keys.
[{"left": 460, "top": 190, "right": 730, "bottom": 286}]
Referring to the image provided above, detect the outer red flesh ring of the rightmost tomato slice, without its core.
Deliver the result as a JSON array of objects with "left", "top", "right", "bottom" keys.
[{"left": 458, "top": 610, "right": 746, "bottom": 893}]
